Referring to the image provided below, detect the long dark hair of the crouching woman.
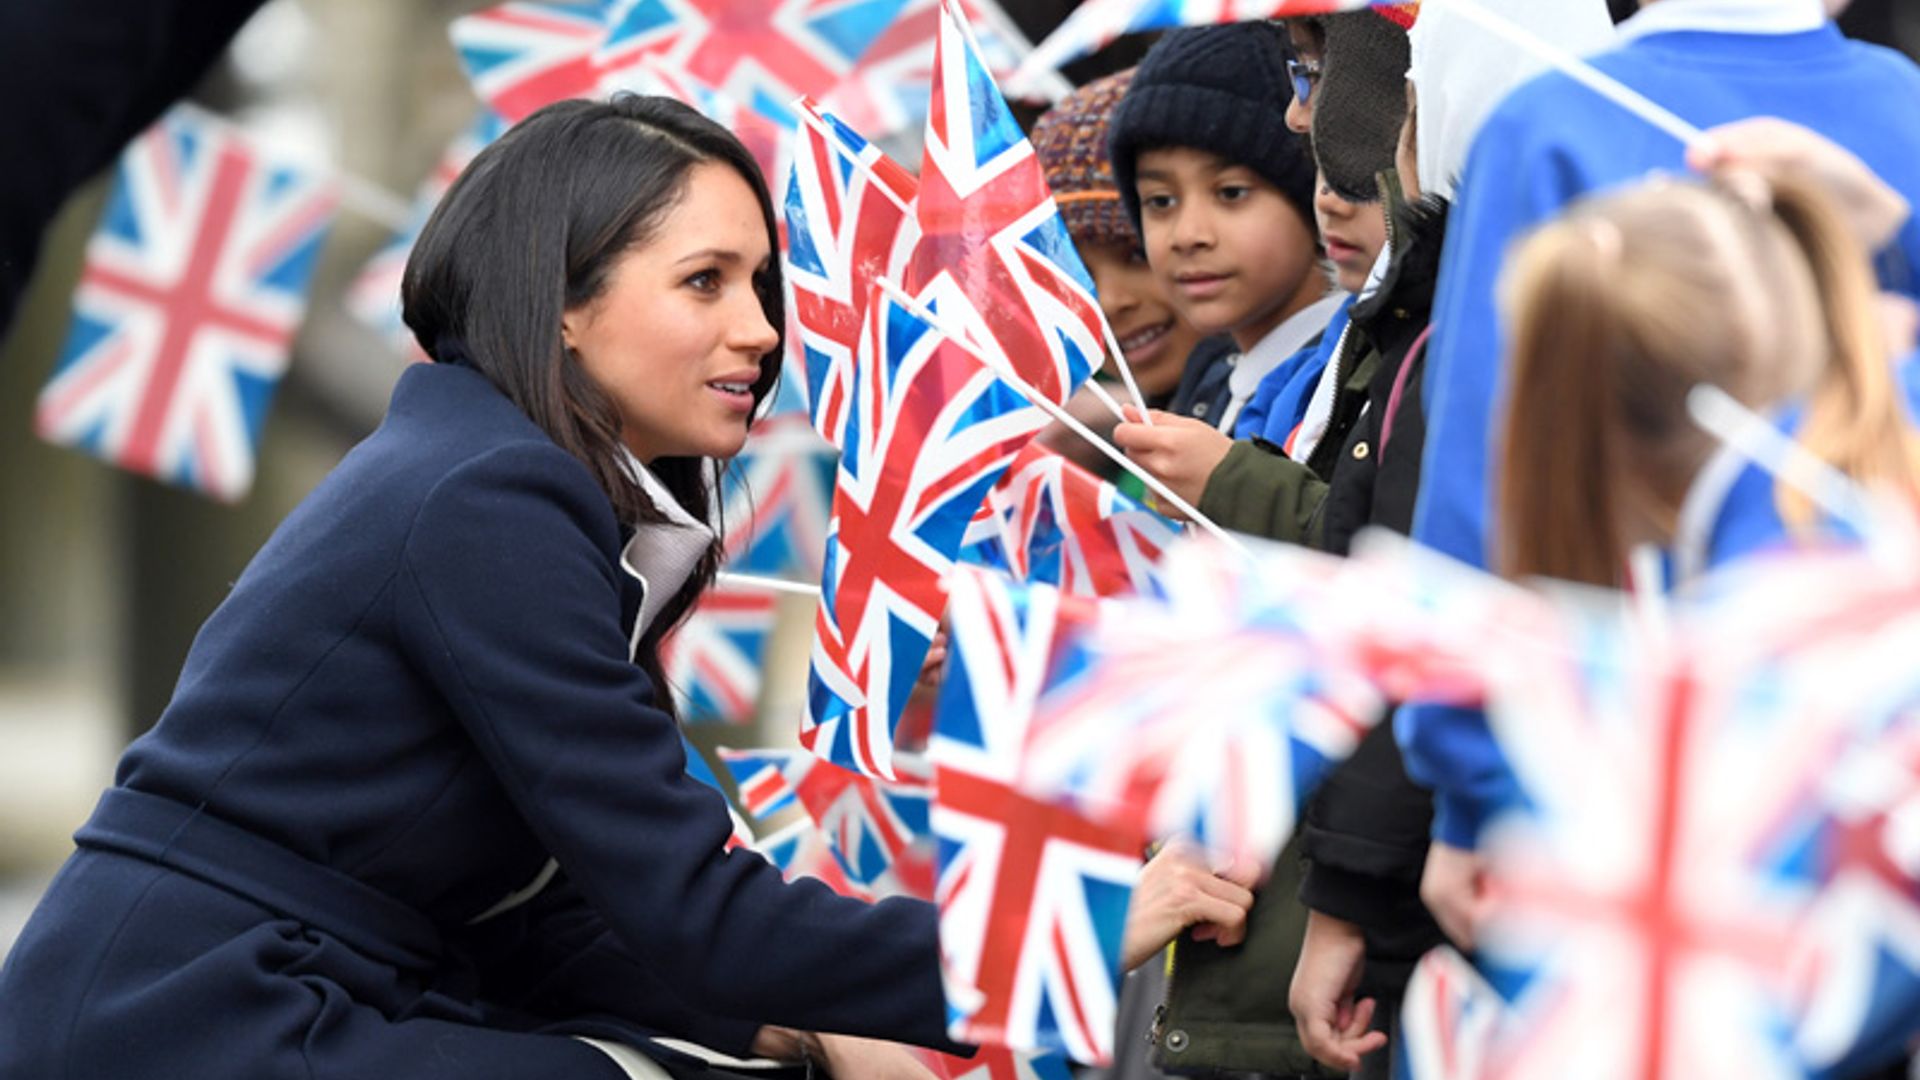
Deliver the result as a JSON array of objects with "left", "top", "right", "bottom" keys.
[{"left": 401, "top": 94, "right": 787, "bottom": 711}]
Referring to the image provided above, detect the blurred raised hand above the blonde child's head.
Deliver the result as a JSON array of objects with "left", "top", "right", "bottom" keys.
[{"left": 1686, "top": 117, "right": 1912, "bottom": 252}]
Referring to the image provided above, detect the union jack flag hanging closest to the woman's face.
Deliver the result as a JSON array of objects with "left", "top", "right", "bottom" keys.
[{"left": 785, "top": 100, "right": 920, "bottom": 446}]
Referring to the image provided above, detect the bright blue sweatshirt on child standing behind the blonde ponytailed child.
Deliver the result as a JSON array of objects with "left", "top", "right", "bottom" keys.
[{"left": 1396, "top": 23, "right": 1920, "bottom": 847}]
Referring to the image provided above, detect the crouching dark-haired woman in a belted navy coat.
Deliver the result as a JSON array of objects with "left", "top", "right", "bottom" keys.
[{"left": 0, "top": 96, "right": 967, "bottom": 1080}]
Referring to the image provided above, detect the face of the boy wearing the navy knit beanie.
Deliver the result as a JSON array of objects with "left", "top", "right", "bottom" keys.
[{"left": 1135, "top": 146, "right": 1321, "bottom": 350}]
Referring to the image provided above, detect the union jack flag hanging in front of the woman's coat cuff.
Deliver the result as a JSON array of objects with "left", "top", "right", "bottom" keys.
[{"left": 929, "top": 573, "right": 1140, "bottom": 1061}]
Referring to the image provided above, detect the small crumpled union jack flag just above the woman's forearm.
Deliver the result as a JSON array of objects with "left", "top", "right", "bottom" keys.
[{"left": 720, "top": 749, "right": 931, "bottom": 897}]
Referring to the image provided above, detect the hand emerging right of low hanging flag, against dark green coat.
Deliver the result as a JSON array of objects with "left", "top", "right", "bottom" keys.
[{"left": 1119, "top": 840, "right": 1260, "bottom": 970}]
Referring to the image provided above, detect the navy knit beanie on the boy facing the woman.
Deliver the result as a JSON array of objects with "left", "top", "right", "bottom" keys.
[{"left": 1106, "top": 23, "right": 1313, "bottom": 229}]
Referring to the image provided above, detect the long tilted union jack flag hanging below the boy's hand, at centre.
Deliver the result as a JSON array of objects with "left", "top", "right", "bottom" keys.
[{"left": 801, "top": 286, "right": 1046, "bottom": 778}]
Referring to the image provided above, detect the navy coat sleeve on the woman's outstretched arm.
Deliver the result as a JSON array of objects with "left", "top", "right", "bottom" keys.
[{"left": 397, "top": 434, "right": 950, "bottom": 1047}]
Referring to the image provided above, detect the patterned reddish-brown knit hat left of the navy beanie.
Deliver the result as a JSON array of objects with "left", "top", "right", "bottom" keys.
[{"left": 1031, "top": 67, "right": 1140, "bottom": 248}]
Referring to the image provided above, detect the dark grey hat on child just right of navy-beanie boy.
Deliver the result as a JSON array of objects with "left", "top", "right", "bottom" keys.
[{"left": 1313, "top": 12, "right": 1411, "bottom": 202}]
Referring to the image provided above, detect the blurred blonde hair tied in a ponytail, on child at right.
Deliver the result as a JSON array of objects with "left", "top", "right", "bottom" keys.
[{"left": 1498, "top": 177, "right": 1920, "bottom": 584}]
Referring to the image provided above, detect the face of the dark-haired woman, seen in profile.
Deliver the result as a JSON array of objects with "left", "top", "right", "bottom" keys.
[{"left": 561, "top": 161, "right": 780, "bottom": 463}]
